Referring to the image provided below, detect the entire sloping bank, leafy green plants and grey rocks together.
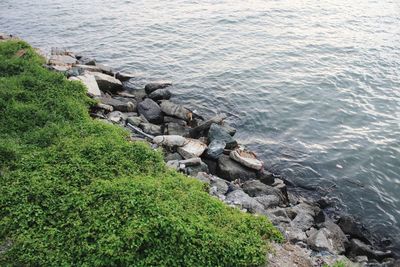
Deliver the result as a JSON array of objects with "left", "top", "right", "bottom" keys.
[{"left": 0, "top": 34, "right": 399, "bottom": 266}]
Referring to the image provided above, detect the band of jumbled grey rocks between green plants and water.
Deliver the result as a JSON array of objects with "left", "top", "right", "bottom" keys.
[{"left": 0, "top": 31, "right": 400, "bottom": 266}]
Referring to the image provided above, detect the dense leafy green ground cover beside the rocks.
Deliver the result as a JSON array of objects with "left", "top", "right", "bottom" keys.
[{"left": 0, "top": 41, "right": 282, "bottom": 266}]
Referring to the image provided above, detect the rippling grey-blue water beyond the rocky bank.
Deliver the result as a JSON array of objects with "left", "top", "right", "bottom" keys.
[{"left": 0, "top": 0, "right": 400, "bottom": 251}]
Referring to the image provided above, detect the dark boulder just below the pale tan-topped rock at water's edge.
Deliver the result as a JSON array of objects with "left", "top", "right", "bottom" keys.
[{"left": 217, "top": 155, "right": 257, "bottom": 181}]
